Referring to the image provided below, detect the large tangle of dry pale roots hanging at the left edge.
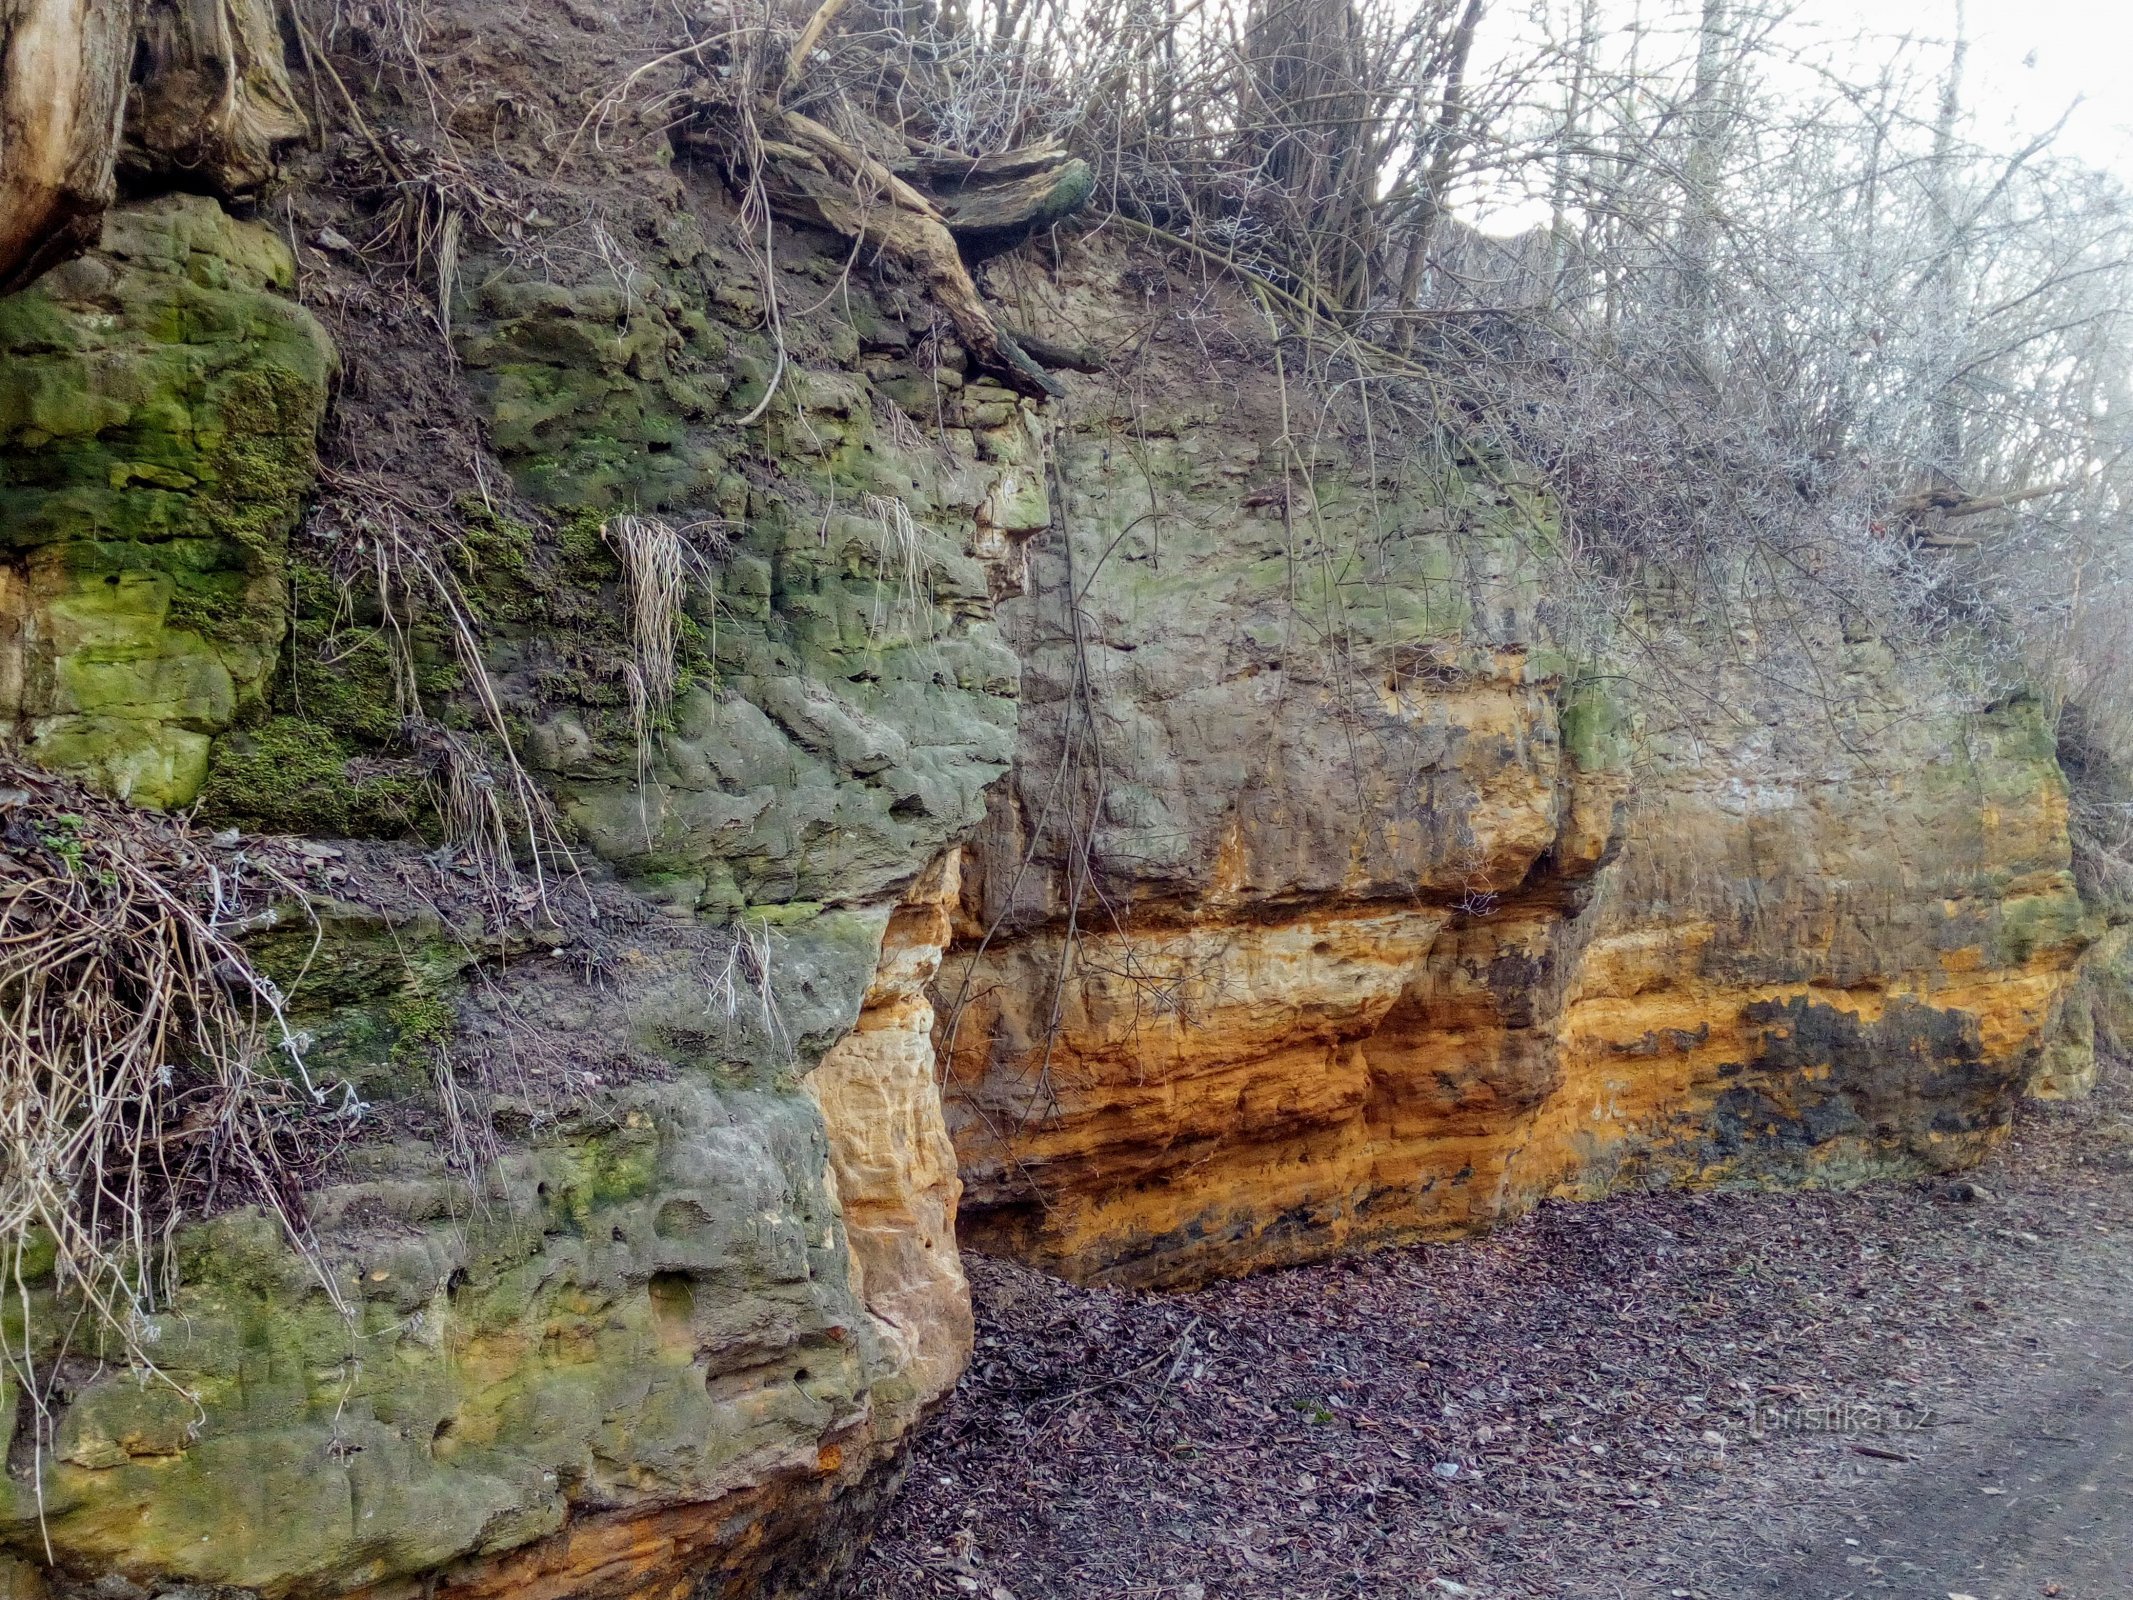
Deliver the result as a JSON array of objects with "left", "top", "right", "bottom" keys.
[{"left": 0, "top": 757, "right": 352, "bottom": 1399}]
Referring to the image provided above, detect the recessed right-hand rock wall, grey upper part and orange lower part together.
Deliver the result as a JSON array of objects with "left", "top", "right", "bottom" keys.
[{"left": 939, "top": 332, "right": 2090, "bottom": 1284}]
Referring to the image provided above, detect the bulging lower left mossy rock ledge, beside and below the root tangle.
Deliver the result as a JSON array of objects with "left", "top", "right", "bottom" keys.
[{"left": 0, "top": 905, "right": 934, "bottom": 1596}]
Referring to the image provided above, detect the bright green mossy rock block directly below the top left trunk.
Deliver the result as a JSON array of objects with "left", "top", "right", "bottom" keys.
[{"left": 0, "top": 196, "right": 335, "bottom": 806}]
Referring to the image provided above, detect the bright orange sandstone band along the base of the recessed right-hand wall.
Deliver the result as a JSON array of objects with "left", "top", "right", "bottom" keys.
[{"left": 943, "top": 725, "right": 2086, "bottom": 1284}]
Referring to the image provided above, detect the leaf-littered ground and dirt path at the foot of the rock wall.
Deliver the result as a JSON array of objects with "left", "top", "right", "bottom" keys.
[{"left": 851, "top": 1071, "right": 2133, "bottom": 1600}]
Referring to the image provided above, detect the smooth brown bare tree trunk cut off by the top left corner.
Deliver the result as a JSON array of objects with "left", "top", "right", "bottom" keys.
[{"left": 0, "top": 0, "right": 137, "bottom": 292}]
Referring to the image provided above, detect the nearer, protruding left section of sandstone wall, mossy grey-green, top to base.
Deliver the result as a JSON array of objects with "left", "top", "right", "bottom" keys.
[{"left": 0, "top": 178, "right": 1047, "bottom": 1600}]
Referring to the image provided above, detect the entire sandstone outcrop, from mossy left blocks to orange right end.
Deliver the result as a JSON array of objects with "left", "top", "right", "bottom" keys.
[{"left": 0, "top": 18, "right": 2122, "bottom": 1600}]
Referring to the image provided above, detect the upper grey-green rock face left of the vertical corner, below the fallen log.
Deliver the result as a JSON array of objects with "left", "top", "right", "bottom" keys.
[{"left": 459, "top": 234, "right": 1049, "bottom": 915}]
